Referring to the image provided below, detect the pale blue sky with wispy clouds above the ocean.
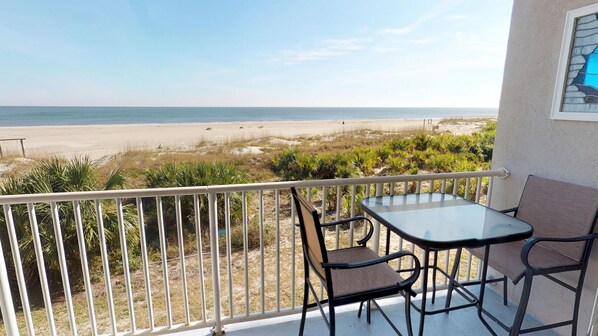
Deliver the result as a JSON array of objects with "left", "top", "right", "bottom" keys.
[{"left": 0, "top": 0, "right": 512, "bottom": 107}]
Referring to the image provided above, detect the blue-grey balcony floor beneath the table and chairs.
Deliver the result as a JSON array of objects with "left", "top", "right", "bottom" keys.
[{"left": 176, "top": 291, "right": 570, "bottom": 336}]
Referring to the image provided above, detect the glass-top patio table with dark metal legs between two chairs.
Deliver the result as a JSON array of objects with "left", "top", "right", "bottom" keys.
[{"left": 361, "top": 193, "right": 534, "bottom": 335}]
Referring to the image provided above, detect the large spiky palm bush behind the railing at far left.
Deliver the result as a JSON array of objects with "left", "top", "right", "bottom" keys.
[{"left": 0, "top": 157, "right": 139, "bottom": 290}]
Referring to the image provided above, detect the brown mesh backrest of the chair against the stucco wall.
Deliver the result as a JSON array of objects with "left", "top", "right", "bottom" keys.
[{"left": 517, "top": 175, "right": 598, "bottom": 260}]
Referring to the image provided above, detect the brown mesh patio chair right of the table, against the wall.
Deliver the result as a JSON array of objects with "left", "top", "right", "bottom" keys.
[{"left": 447, "top": 175, "right": 598, "bottom": 335}]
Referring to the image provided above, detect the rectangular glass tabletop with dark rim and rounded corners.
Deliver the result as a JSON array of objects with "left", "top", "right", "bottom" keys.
[{"left": 361, "top": 193, "right": 533, "bottom": 247}]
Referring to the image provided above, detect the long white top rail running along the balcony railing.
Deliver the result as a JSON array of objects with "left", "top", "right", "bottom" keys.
[{"left": 0, "top": 168, "right": 509, "bottom": 205}]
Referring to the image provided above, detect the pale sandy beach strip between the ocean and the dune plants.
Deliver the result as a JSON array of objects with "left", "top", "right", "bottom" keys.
[{"left": 0, "top": 119, "right": 490, "bottom": 159}]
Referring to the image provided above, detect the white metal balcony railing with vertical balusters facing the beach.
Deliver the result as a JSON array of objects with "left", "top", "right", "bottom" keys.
[{"left": 0, "top": 168, "right": 508, "bottom": 335}]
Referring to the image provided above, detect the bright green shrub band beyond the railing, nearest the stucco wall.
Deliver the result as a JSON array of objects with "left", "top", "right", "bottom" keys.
[{"left": 270, "top": 122, "right": 496, "bottom": 180}]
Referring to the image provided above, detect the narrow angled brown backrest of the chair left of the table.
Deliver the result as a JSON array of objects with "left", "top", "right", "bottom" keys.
[{"left": 291, "top": 187, "right": 328, "bottom": 283}]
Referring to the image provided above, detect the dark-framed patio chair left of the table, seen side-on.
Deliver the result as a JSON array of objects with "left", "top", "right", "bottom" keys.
[{"left": 291, "top": 188, "right": 420, "bottom": 336}]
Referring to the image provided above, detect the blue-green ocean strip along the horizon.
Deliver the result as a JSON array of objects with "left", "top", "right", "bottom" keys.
[{"left": 0, "top": 106, "right": 498, "bottom": 127}]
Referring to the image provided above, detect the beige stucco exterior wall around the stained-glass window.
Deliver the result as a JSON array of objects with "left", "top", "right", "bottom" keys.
[{"left": 492, "top": 0, "right": 598, "bottom": 335}]
